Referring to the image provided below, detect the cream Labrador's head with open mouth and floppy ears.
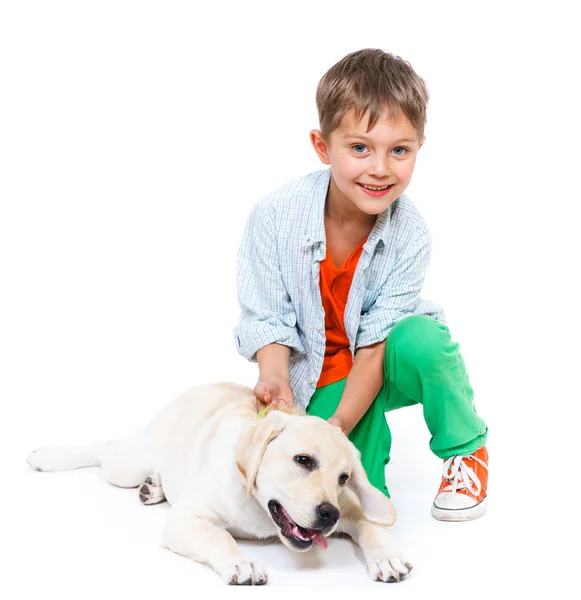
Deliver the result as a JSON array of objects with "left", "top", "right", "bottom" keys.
[{"left": 237, "top": 411, "right": 395, "bottom": 551}]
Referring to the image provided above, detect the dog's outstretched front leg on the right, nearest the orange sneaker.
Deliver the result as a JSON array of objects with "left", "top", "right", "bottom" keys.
[{"left": 337, "top": 492, "right": 413, "bottom": 583}]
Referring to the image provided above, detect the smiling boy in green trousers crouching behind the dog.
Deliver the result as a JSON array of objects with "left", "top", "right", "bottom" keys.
[{"left": 234, "top": 49, "right": 488, "bottom": 521}]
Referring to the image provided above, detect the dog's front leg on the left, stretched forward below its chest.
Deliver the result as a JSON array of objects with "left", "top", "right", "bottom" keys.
[{"left": 162, "top": 506, "right": 268, "bottom": 585}]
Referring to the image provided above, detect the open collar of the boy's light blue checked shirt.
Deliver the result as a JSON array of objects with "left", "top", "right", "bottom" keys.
[{"left": 305, "top": 168, "right": 393, "bottom": 252}]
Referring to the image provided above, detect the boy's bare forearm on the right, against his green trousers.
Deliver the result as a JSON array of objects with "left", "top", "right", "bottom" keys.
[{"left": 329, "top": 341, "right": 386, "bottom": 435}]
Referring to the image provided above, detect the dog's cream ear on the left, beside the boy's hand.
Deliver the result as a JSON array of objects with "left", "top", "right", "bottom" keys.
[{"left": 236, "top": 412, "right": 286, "bottom": 496}]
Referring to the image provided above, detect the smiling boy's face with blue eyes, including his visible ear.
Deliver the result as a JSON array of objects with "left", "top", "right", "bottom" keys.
[{"left": 311, "top": 111, "right": 426, "bottom": 217}]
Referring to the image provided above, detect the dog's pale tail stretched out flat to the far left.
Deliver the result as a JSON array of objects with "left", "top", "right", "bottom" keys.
[{"left": 26, "top": 441, "right": 113, "bottom": 471}]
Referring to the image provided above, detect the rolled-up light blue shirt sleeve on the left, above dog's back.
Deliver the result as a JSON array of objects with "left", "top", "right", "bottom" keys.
[{"left": 234, "top": 203, "right": 304, "bottom": 362}]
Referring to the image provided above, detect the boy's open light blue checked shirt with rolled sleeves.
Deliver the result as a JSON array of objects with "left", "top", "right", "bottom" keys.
[{"left": 234, "top": 169, "right": 445, "bottom": 409}]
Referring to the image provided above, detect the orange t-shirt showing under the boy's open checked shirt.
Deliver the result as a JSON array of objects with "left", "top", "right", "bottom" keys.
[{"left": 317, "top": 239, "right": 367, "bottom": 388}]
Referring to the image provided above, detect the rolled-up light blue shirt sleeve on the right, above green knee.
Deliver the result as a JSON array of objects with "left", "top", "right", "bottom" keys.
[{"left": 355, "top": 231, "right": 431, "bottom": 349}]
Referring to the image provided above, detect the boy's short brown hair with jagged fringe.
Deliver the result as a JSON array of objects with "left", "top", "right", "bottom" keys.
[{"left": 317, "top": 48, "right": 428, "bottom": 138}]
